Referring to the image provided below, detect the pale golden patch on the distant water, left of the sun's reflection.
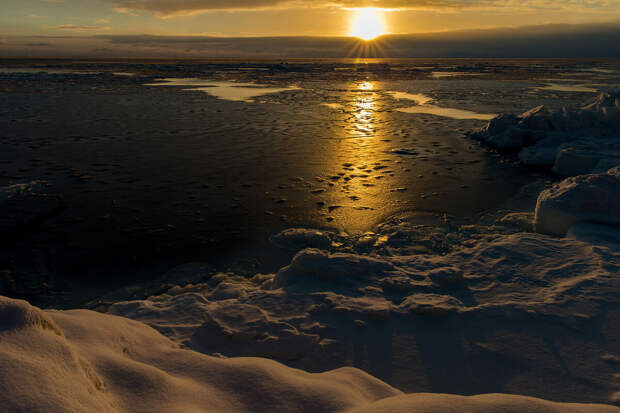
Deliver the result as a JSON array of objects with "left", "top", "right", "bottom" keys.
[{"left": 146, "top": 78, "right": 299, "bottom": 102}]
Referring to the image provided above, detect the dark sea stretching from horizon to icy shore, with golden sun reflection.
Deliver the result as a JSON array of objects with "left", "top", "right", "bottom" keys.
[{"left": 0, "top": 60, "right": 619, "bottom": 305}]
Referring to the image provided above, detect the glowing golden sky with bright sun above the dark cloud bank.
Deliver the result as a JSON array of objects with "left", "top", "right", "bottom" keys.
[{"left": 0, "top": 0, "right": 620, "bottom": 57}]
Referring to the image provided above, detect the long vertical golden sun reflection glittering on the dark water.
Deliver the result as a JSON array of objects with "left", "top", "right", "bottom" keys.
[{"left": 324, "top": 81, "right": 392, "bottom": 232}]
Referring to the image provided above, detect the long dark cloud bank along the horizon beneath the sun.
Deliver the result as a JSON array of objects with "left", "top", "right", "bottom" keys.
[{"left": 0, "top": 23, "right": 620, "bottom": 58}]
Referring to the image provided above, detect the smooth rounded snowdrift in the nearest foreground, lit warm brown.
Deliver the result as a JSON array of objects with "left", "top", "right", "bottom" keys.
[{"left": 0, "top": 297, "right": 620, "bottom": 413}]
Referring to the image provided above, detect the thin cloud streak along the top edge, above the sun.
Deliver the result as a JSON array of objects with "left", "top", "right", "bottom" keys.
[{"left": 106, "top": 0, "right": 620, "bottom": 17}]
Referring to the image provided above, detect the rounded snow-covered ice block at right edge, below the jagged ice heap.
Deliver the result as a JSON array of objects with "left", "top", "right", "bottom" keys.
[{"left": 535, "top": 168, "right": 620, "bottom": 236}]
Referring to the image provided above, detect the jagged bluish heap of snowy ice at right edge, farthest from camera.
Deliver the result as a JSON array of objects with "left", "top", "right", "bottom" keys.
[{"left": 470, "top": 92, "right": 620, "bottom": 176}]
